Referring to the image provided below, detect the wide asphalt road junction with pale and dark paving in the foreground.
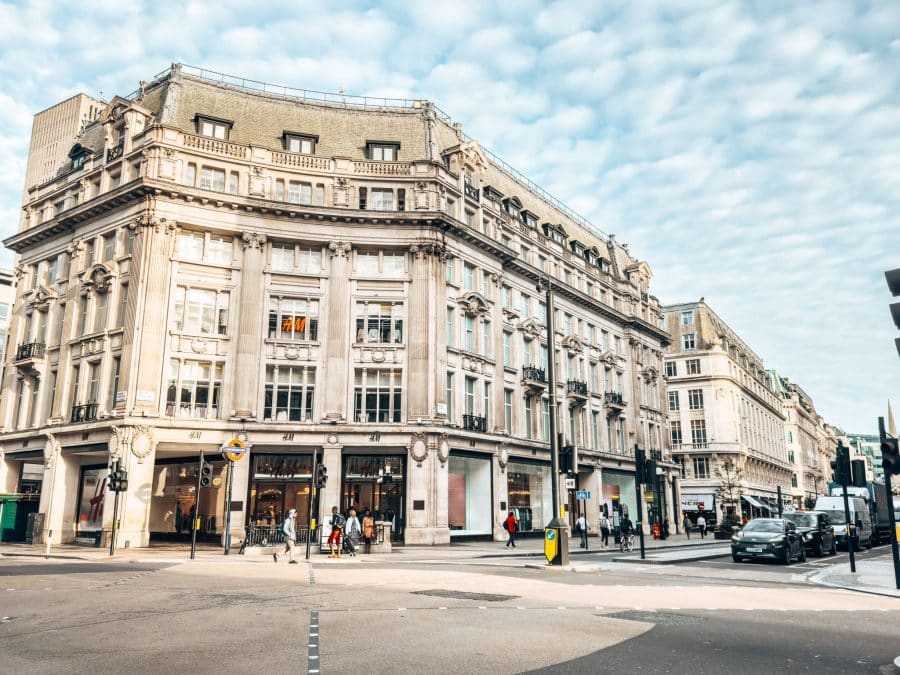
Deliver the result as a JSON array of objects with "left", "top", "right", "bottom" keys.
[{"left": 0, "top": 558, "right": 900, "bottom": 675}]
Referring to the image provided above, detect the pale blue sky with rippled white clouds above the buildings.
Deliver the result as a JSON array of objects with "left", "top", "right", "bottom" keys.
[{"left": 0, "top": 0, "right": 900, "bottom": 432}]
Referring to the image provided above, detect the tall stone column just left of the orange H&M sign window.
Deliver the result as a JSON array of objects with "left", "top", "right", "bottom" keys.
[{"left": 231, "top": 232, "right": 266, "bottom": 419}]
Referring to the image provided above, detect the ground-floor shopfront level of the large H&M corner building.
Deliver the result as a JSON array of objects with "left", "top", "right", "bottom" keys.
[{"left": 0, "top": 424, "right": 671, "bottom": 547}]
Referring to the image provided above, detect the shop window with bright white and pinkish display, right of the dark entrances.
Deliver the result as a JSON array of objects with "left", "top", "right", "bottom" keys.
[{"left": 448, "top": 455, "right": 493, "bottom": 536}]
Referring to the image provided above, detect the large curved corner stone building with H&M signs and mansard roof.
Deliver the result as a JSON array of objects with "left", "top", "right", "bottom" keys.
[{"left": 0, "top": 65, "right": 677, "bottom": 546}]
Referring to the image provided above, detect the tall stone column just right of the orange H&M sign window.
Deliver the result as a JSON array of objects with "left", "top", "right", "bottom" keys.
[{"left": 320, "top": 241, "right": 351, "bottom": 422}]
